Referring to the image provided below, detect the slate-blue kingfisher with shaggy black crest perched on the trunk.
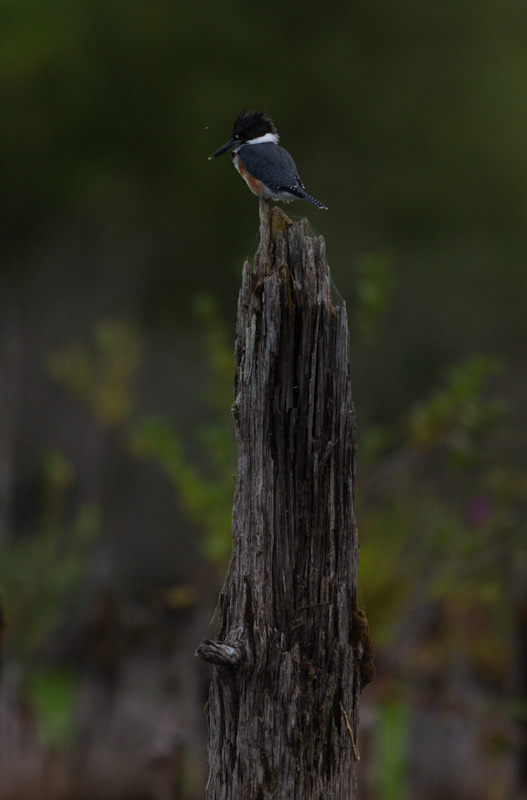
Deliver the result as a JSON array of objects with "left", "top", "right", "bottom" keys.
[{"left": 209, "top": 108, "right": 327, "bottom": 210}]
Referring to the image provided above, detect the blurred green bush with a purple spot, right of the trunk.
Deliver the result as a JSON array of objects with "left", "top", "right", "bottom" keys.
[{"left": 357, "top": 357, "right": 527, "bottom": 668}]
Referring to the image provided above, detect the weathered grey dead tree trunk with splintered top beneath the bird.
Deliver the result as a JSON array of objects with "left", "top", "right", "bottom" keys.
[{"left": 197, "top": 208, "right": 369, "bottom": 800}]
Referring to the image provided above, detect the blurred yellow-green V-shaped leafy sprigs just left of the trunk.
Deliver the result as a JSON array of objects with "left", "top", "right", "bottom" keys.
[{"left": 47, "top": 304, "right": 236, "bottom": 568}]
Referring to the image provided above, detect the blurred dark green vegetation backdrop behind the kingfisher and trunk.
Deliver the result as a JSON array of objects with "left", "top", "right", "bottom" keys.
[{"left": 0, "top": 0, "right": 527, "bottom": 800}]
